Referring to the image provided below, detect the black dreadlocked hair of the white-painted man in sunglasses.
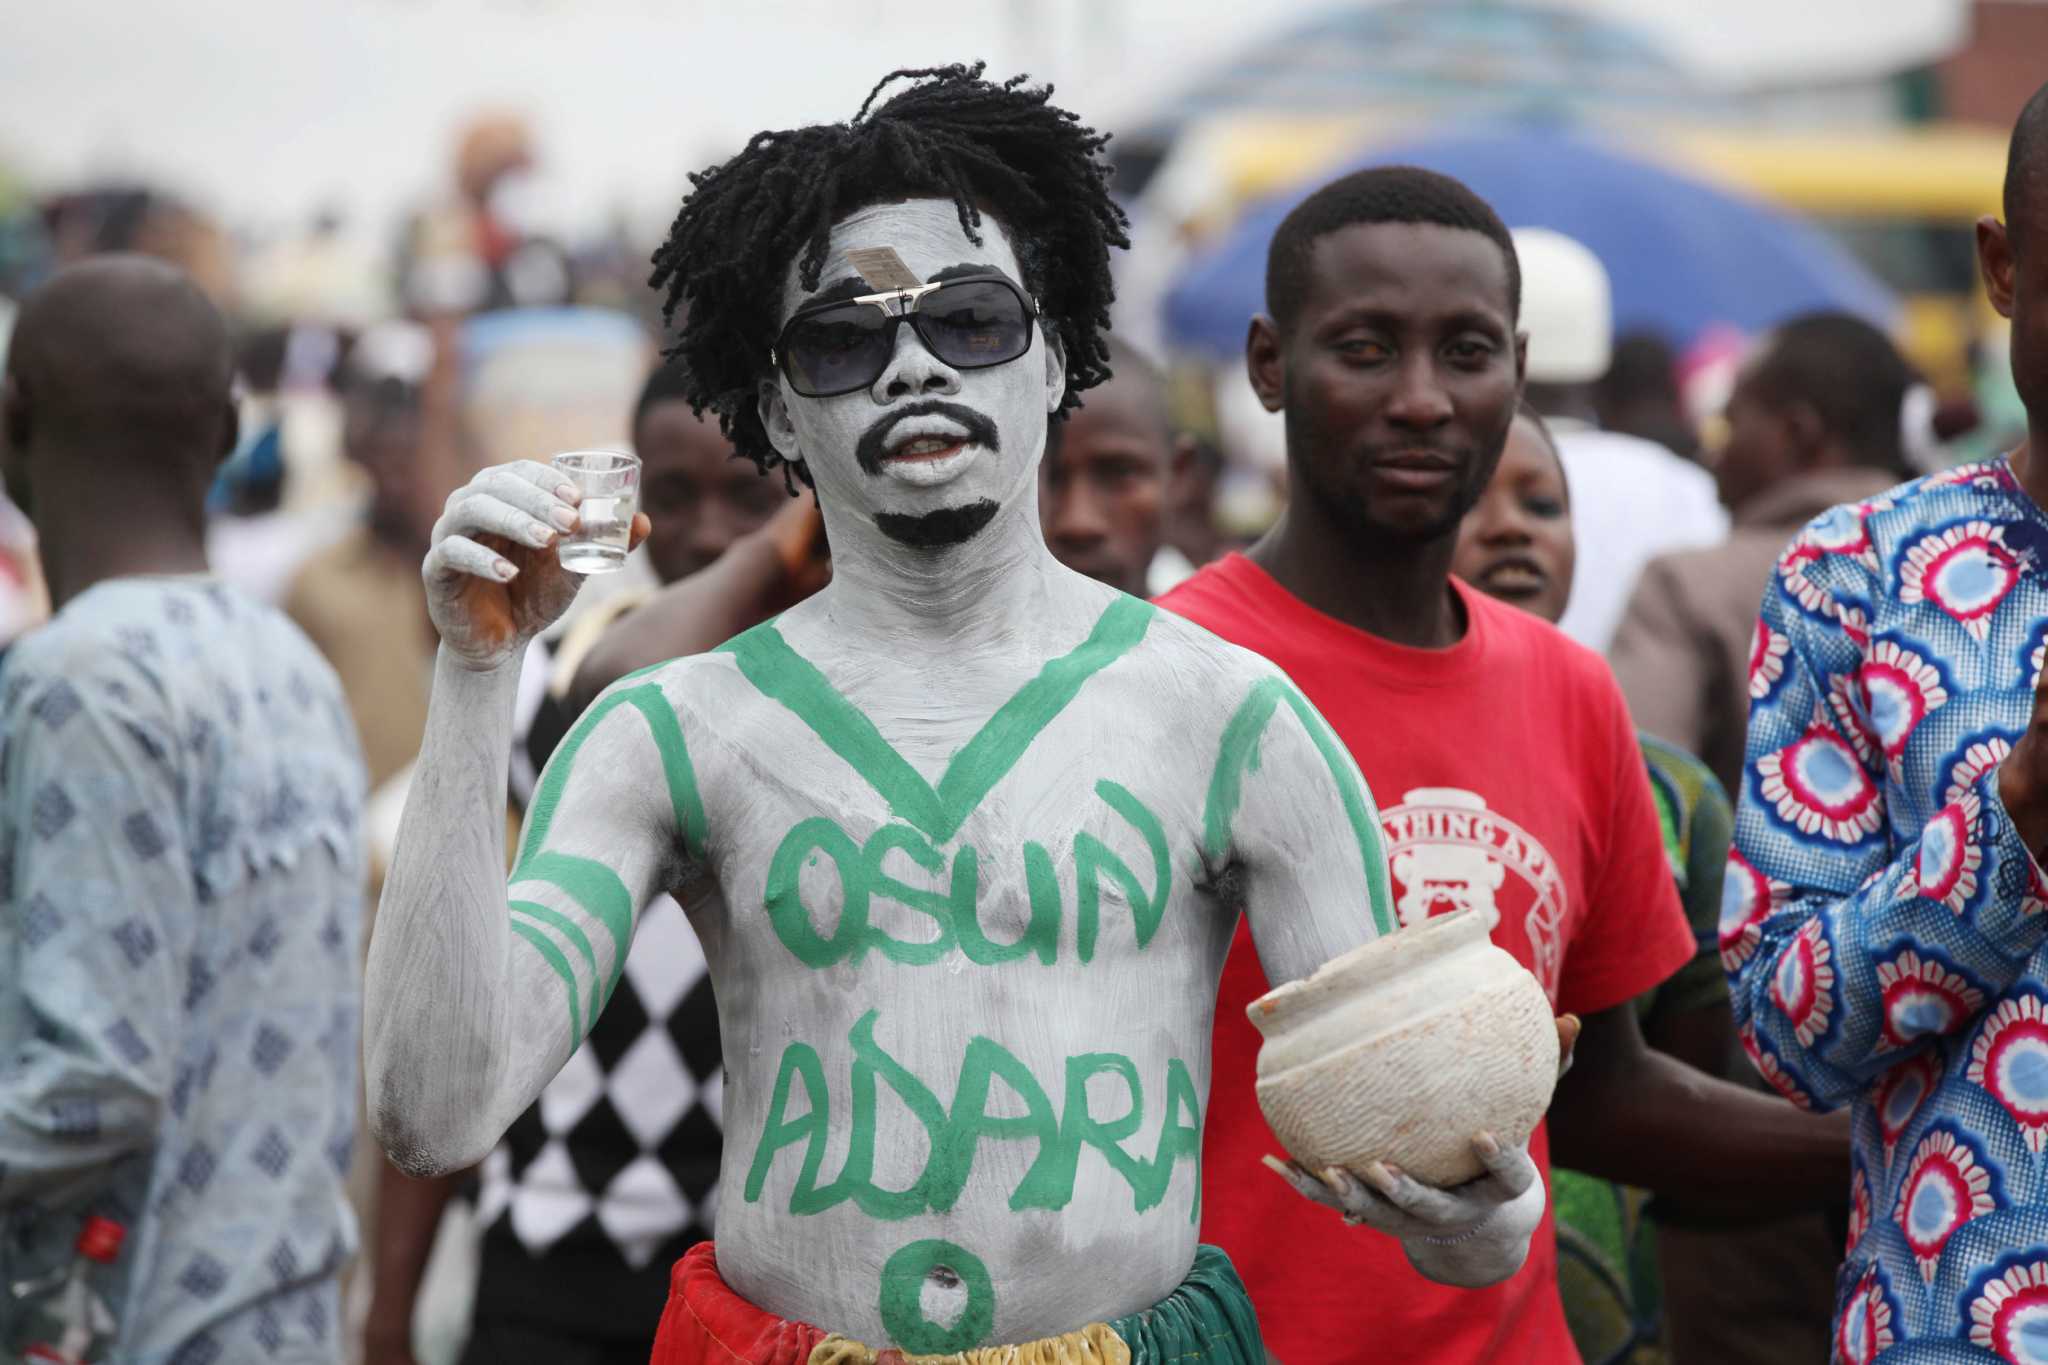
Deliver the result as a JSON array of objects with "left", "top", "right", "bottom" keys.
[{"left": 649, "top": 61, "right": 1130, "bottom": 491}]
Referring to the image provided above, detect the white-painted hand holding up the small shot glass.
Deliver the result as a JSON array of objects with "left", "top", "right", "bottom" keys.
[{"left": 420, "top": 460, "right": 651, "bottom": 671}]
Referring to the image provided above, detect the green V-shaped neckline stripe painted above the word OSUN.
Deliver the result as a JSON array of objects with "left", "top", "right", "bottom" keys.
[{"left": 719, "top": 598, "right": 1157, "bottom": 843}]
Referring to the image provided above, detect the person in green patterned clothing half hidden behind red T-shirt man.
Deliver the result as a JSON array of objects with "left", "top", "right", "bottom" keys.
[{"left": 1452, "top": 409, "right": 1839, "bottom": 1365}]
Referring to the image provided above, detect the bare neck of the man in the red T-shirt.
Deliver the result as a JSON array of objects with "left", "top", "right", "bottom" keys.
[{"left": 1247, "top": 497, "right": 1464, "bottom": 649}]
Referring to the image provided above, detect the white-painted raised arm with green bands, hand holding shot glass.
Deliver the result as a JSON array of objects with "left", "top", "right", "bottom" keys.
[{"left": 365, "top": 463, "right": 680, "bottom": 1177}]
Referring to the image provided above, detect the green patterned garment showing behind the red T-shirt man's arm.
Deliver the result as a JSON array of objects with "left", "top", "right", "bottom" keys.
[{"left": 1550, "top": 735, "right": 1735, "bottom": 1365}]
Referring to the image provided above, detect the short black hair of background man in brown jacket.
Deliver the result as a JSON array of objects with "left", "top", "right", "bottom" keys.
[{"left": 1749, "top": 313, "right": 1919, "bottom": 473}]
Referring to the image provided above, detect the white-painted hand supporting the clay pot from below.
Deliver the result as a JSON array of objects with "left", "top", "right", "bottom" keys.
[{"left": 1266, "top": 1134, "right": 1544, "bottom": 1289}]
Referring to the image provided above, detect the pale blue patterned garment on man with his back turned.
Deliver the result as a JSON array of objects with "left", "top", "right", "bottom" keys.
[{"left": 0, "top": 579, "right": 362, "bottom": 1365}]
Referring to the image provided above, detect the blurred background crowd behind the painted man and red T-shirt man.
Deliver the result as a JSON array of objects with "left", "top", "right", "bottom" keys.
[{"left": 0, "top": 72, "right": 2038, "bottom": 1365}]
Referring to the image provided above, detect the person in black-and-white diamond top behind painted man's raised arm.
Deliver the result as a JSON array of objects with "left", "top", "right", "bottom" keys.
[{"left": 365, "top": 362, "right": 795, "bottom": 1365}]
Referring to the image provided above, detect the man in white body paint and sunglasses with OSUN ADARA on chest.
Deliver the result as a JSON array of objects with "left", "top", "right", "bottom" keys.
[{"left": 367, "top": 68, "right": 1542, "bottom": 1365}]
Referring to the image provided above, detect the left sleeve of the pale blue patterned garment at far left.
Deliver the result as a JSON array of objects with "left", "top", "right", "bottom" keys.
[{"left": 0, "top": 659, "right": 199, "bottom": 1207}]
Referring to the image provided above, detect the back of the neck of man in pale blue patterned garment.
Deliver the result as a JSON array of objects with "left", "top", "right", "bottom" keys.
[{"left": 35, "top": 465, "right": 207, "bottom": 610}]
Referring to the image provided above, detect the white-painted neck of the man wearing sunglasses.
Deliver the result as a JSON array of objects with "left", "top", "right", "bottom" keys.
[{"left": 819, "top": 497, "right": 1079, "bottom": 651}]
